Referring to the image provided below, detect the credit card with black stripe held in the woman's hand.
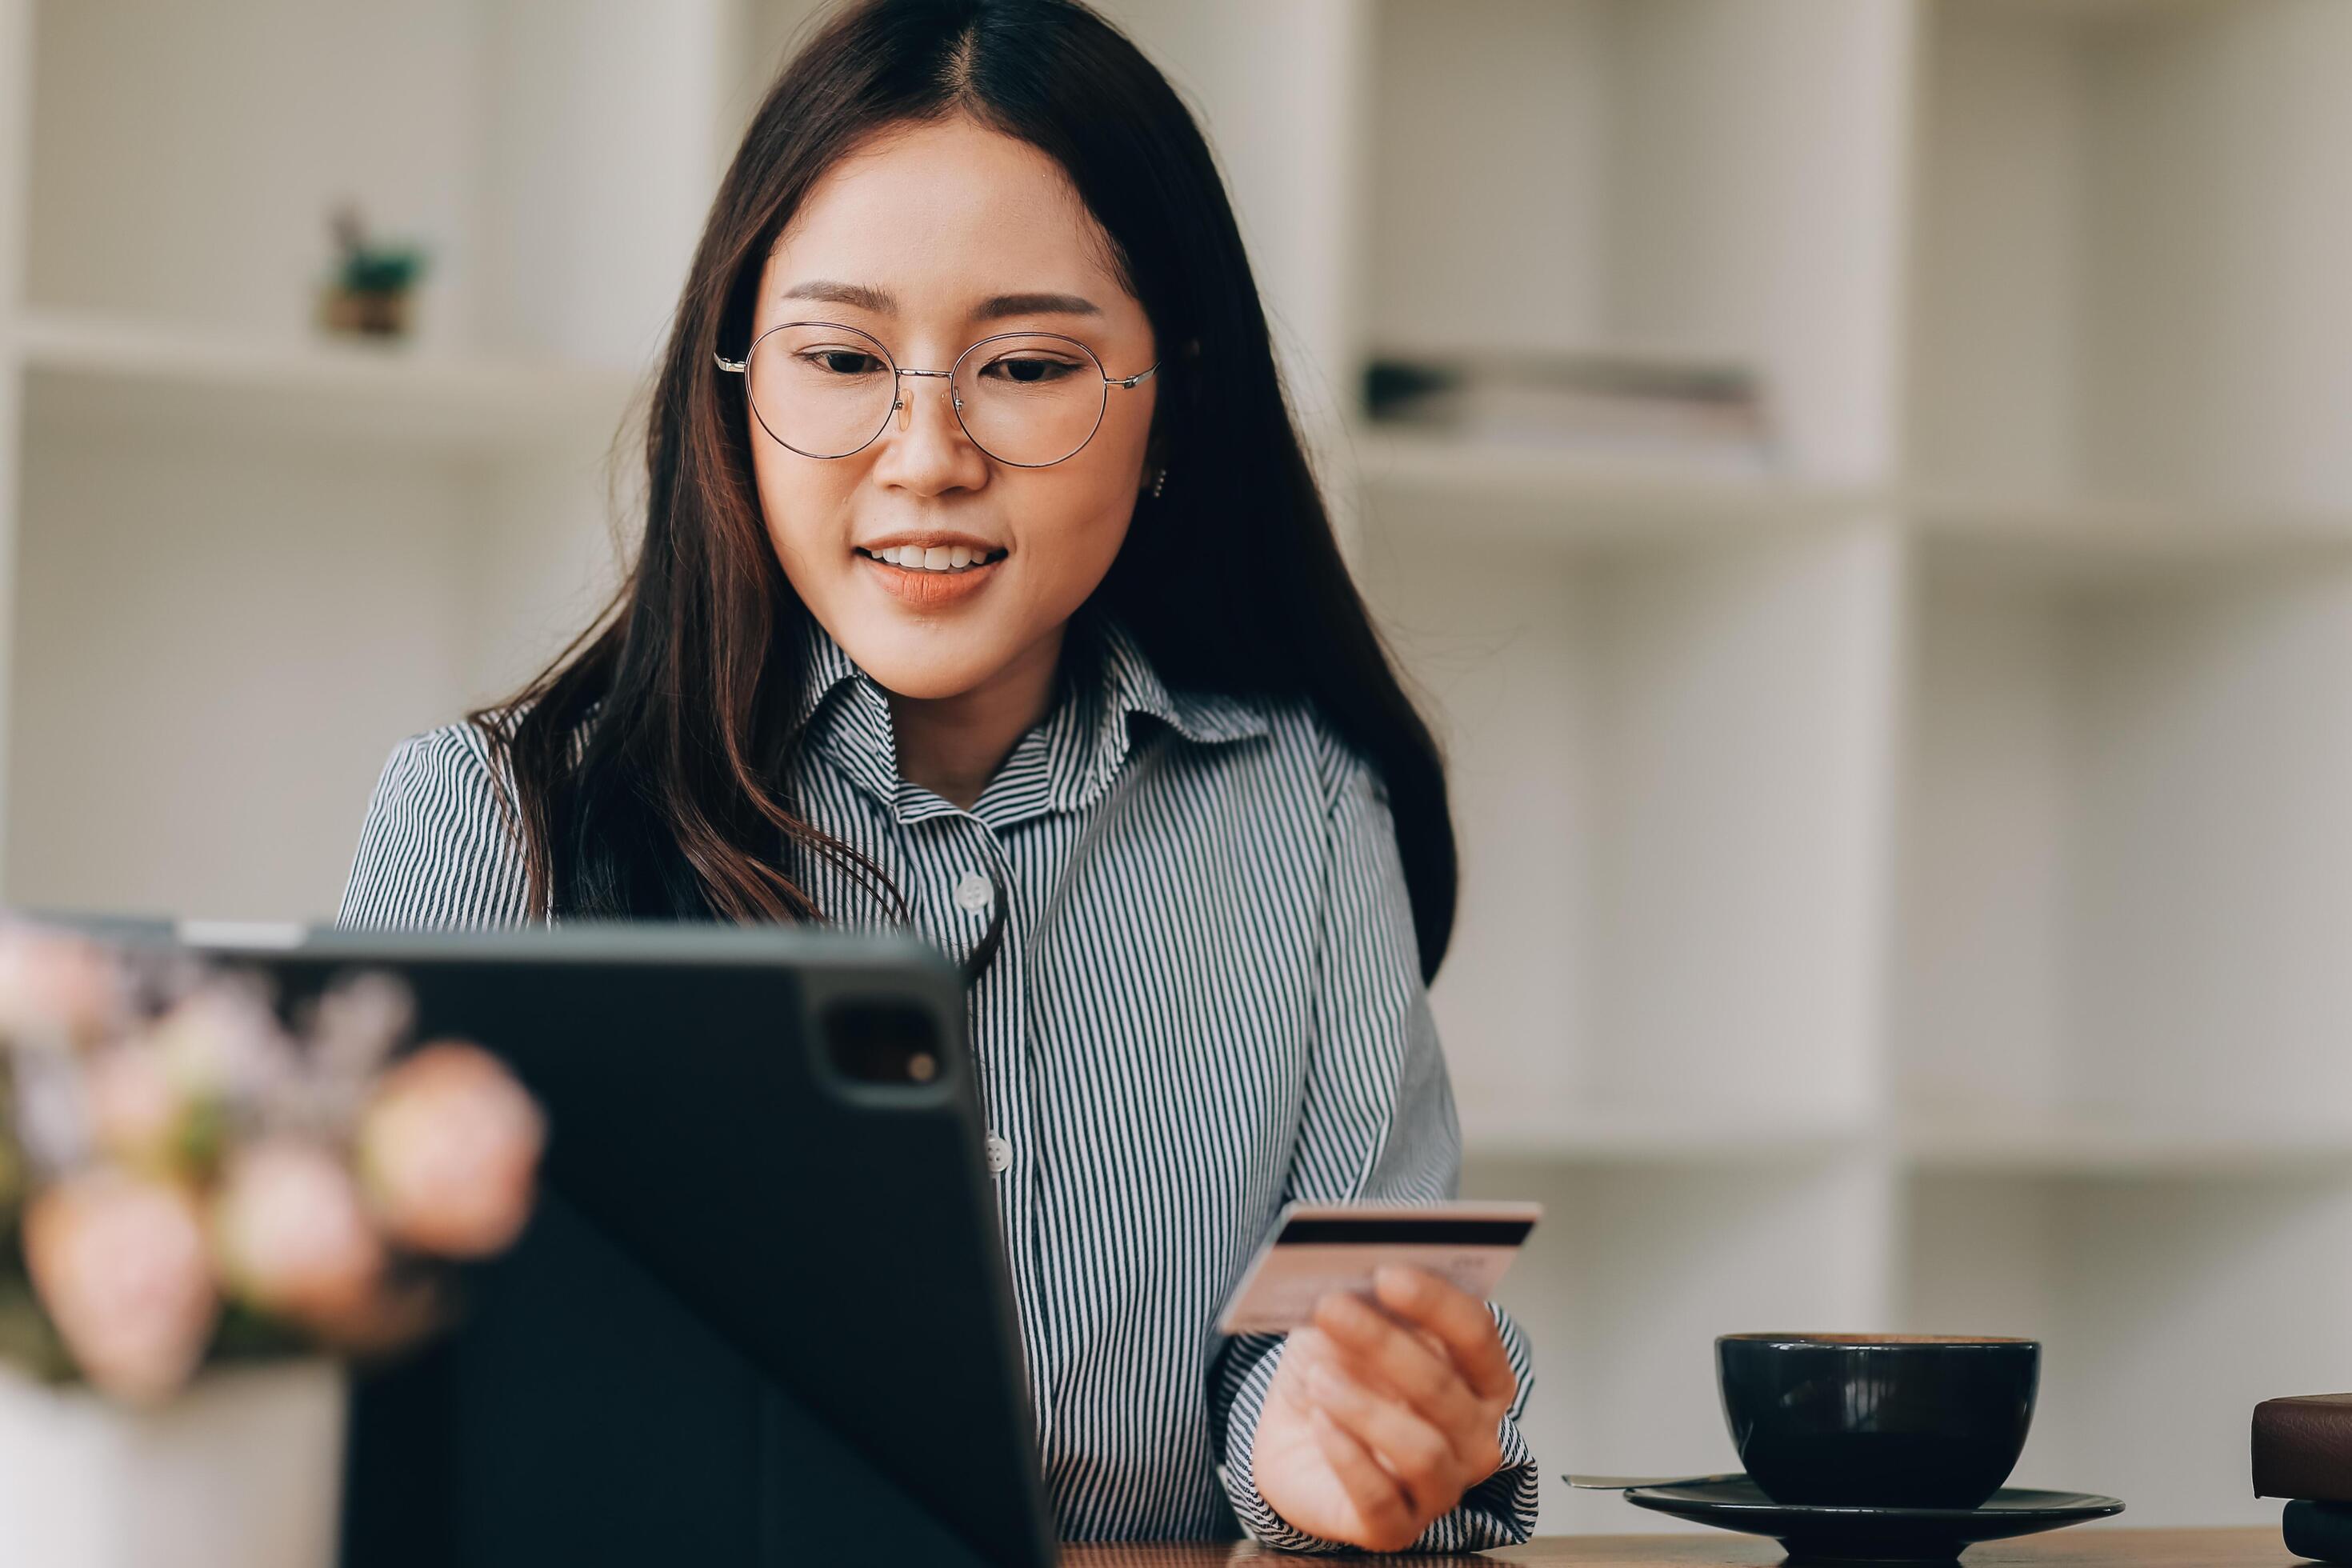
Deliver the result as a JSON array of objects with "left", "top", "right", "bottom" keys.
[{"left": 1216, "top": 1202, "right": 1543, "bottom": 1333}]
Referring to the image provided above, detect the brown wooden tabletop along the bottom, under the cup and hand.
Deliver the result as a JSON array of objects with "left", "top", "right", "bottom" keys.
[{"left": 1061, "top": 1526, "right": 2302, "bottom": 1568}]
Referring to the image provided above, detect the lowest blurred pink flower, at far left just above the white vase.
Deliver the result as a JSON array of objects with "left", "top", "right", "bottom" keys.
[{"left": 23, "top": 1168, "right": 221, "bottom": 1401}]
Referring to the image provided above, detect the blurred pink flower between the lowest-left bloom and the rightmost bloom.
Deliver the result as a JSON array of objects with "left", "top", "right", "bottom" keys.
[{"left": 212, "top": 1138, "right": 386, "bottom": 1323}]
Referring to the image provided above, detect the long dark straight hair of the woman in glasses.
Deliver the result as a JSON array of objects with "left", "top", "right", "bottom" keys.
[{"left": 468, "top": 0, "right": 1456, "bottom": 978}]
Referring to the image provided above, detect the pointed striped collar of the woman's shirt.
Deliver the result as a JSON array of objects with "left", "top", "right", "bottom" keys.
[{"left": 793, "top": 602, "right": 1268, "bottom": 825}]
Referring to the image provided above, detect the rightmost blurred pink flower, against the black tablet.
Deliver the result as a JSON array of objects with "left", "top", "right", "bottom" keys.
[{"left": 358, "top": 1039, "right": 546, "bottom": 1258}]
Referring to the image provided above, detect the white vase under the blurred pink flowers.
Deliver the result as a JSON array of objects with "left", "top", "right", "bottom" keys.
[{"left": 0, "top": 1357, "right": 348, "bottom": 1568}]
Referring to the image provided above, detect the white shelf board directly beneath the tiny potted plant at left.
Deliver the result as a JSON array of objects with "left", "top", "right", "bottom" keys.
[{"left": 17, "top": 310, "right": 633, "bottom": 451}]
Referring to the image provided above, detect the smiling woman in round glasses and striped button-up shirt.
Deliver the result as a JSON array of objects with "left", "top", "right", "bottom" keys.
[{"left": 341, "top": 0, "right": 1536, "bottom": 1549}]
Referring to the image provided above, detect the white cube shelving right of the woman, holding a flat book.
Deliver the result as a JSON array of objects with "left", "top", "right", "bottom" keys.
[{"left": 1326, "top": 0, "right": 2352, "bottom": 1530}]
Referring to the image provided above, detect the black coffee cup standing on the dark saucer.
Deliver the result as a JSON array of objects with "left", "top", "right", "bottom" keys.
[{"left": 1714, "top": 1333, "right": 2042, "bottom": 1510}]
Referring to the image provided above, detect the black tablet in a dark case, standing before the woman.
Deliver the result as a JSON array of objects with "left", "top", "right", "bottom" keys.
[{"left": 113, "top": 922, "right": 1056, "bottom": 1568}]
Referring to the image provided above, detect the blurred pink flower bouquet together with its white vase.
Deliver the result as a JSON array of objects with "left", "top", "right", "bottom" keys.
[{"left": 0, "top": 914, "right": 546, "bottom": 1568}]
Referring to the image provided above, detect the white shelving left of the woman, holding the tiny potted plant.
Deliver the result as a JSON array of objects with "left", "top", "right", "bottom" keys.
[{"left": 0, "top": 0, "right": 738, "bottom": 917}]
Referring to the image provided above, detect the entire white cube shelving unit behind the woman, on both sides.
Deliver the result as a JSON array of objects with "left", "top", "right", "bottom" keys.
[{"left": 0, "top": 0, "right": 2352, "bottom": 1530}]
